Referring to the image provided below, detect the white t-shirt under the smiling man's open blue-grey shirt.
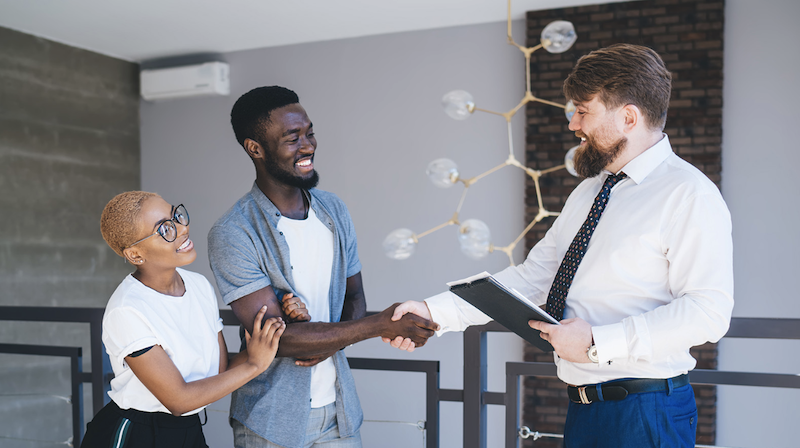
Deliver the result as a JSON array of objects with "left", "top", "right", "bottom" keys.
[{"left": 278, "top": 208, "right": 336, "bottom": 408}]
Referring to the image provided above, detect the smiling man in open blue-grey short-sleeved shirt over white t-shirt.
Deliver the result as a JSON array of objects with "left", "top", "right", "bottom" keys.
[{"left": 208, "top": 86, "right": 437, "bottom": 448}]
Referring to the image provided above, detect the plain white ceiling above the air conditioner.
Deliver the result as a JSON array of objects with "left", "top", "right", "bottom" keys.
[{"left": 0, "top": 0, "right": 625, "bottom": 62}]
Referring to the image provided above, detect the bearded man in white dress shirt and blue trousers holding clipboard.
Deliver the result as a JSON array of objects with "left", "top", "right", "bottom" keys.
[{"left": 387, "top": 44, "right": 733, "bottom": 448}]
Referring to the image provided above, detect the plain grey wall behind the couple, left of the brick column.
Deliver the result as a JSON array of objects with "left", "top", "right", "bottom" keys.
[{"left": 141, "top": 21, "right": 532, "bottom": 447}]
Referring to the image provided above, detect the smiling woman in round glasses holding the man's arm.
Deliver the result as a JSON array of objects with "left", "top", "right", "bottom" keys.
[{"left": 81, "top": 191, "right": 285, "bottom": 447}]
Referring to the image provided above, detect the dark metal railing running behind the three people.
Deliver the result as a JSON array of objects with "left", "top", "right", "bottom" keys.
[{"left": 0, "top": 306, "right": 800, "bottom": 448}]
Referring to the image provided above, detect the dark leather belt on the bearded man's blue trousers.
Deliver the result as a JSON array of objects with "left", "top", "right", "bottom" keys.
[{"left": 567, "top": 373, "right": 689, "bottom": 404}]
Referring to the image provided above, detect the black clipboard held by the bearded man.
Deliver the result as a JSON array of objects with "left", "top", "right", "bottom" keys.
[{"left": 447, "top": 272, "right": 560, "bottom": 352}]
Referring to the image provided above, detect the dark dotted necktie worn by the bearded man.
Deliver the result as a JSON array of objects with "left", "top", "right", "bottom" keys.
[{"left": 547, "top": 173, "right": 628, "bottom": 320}]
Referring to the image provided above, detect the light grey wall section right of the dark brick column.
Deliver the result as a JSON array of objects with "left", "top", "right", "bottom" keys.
[{"left": 717, "top": 0, "right": 800, "bottom": 448}]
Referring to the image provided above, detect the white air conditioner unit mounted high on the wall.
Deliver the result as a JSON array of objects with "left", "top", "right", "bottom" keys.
[{"left": 140, "top": 62, "right": 231, "bottom": 101}]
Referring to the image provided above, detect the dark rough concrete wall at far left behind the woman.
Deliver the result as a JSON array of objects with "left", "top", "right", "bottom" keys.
[{"left": 0, "top": 28, "right": 139, "bottom": 447}]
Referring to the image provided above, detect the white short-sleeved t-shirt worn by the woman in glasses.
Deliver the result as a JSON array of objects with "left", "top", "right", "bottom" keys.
[{"left": 103, "top": 268, "right": 222, "bottom": 415}]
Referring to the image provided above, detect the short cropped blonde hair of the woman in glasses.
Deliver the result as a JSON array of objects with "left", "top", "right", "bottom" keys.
[{"left": 100, "top": 191, "right": 161, "bottom": 257}]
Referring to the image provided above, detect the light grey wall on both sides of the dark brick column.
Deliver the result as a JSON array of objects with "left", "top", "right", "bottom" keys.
[{"left": 142, "top": 0, "right": 800, "bottom": 447}]
